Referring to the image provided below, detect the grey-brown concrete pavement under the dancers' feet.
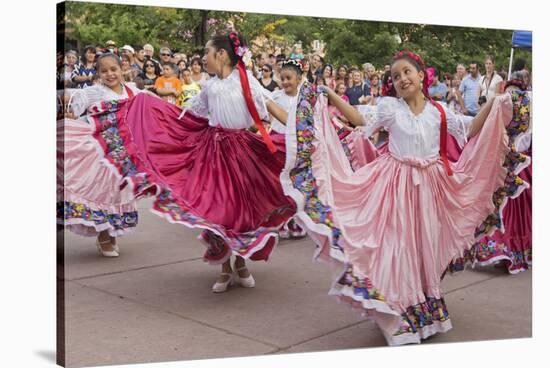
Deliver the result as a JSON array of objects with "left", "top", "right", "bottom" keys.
[{"left": 58, "top": 200, "right": 532, "bottom": 367}]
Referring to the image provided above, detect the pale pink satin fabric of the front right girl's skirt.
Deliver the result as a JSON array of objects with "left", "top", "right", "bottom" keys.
[{"left": 310, "top": 96, "right": 512, "bottom": 320}]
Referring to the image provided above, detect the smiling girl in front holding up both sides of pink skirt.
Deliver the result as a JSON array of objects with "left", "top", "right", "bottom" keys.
[{"left": 281, "top": 51, "right": 523, "bottom": 345}]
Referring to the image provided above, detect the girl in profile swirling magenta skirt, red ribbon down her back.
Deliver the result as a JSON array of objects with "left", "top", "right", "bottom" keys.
[{"left": 75, "top": 33, "right": 295, "bottom": 292}]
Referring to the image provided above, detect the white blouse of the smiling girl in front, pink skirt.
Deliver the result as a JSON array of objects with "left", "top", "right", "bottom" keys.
[{"left": 358, "top": 97, "right": 473, "bottom": 159}]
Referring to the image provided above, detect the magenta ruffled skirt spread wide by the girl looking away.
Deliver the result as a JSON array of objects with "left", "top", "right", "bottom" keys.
[{"left": 80, "top": 94, "right": 295, "bottom": 263}]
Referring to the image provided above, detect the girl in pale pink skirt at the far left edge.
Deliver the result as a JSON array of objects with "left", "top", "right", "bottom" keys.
[{"left": 57, "top": 54, "right": 144, "bottom": 257}]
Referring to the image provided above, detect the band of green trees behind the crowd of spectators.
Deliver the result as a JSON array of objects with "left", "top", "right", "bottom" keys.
[{"left": 65, "top": 2, "right": 531, "bottom": 72}]
